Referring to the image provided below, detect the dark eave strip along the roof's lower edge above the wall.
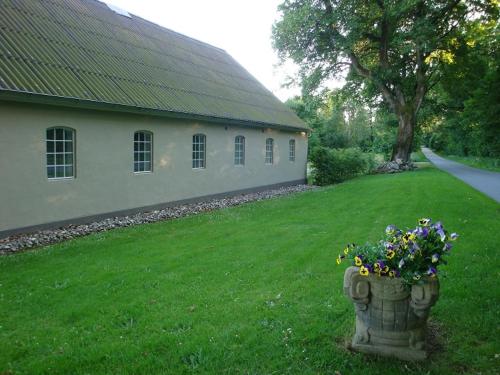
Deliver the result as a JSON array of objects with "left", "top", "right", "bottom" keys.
[{"left": 0, "top": 89, "right": 311, "bottom": 132}]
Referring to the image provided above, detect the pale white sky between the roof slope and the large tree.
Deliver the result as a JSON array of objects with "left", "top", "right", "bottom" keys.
[{"left": 105, "top": 0, "right": 300, "bottom": 101}]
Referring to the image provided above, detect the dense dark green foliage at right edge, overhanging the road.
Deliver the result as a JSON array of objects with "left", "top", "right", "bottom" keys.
[{"left": 422, "top": 21, "right": 500, "bottom": 158}]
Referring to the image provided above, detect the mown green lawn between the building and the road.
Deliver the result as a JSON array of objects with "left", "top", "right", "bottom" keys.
[{"left": 0, "top": 167, "right": 500, "bottom": 375}]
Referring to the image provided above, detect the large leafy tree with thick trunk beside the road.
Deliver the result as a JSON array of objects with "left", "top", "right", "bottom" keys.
[{"left": 273, "top": 0, "right": 496, "bottom": 162}]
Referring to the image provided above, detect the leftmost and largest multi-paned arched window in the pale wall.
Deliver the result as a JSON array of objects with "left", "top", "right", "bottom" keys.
[{"left": 46, "top": 128, "right": 75, "bottom": 178}]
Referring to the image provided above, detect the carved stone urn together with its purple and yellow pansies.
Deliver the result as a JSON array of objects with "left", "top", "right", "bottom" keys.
[{"left": 337, "top": 218, "right": 458, "bottom": 360}]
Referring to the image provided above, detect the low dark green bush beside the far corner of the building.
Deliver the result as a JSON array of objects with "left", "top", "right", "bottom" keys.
[{"left": 311, "top": 146, "right": 376, "bottom": 185}]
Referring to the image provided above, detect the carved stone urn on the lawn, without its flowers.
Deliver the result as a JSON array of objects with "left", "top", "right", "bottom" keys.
[{"left": 344, "top": 267, "right": 439, "bottom": 361}]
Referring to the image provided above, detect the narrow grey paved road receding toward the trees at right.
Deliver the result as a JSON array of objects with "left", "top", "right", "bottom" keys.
[{"left": 422, "top": 147, "right": 500, "bottom": 202}]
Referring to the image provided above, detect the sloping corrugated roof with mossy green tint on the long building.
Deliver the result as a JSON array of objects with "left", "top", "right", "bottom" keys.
[{"left": 0, "top": 0, "right": 306, "bottom": 129}]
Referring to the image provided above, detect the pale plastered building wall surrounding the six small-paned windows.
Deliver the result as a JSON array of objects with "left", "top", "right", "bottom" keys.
[{"left": 0, "top": 102, "right": 307, "bottom": 232}]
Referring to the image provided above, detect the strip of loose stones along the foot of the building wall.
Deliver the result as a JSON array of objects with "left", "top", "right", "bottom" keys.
[{"left": 0, "top": 185, "right": 316, "bottom": 255}]
